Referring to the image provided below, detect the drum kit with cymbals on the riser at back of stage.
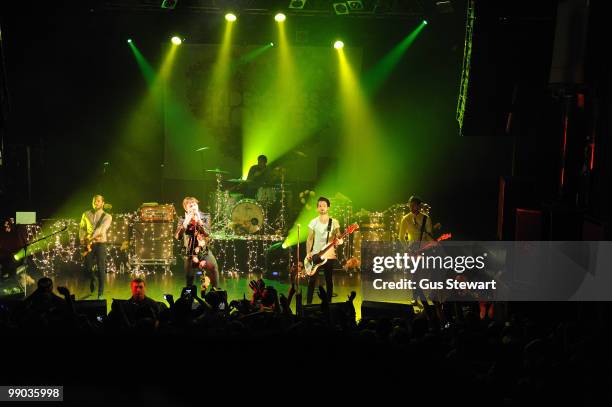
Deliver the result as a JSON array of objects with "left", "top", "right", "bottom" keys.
[{"left": 205, "top": 168, "right": 287, "bottom": 236}]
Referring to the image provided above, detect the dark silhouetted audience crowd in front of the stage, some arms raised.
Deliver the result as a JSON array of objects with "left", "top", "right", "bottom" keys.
[{"left": 0, "top": 278, "right": 604, "bottom": 405}]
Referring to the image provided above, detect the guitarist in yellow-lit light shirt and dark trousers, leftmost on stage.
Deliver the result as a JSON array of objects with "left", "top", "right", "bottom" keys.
[{"left": 79, "top": 195, "right": 113, "bottom": 299}]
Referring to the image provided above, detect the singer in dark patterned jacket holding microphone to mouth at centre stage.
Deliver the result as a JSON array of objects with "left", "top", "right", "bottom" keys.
[{"left": 174, "top": 196, "right": 219, "bottom": 288}]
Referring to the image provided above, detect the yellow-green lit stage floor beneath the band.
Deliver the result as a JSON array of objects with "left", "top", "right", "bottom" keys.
[{"left": 39, "top": 268, "right": 408, "bottom": 319}]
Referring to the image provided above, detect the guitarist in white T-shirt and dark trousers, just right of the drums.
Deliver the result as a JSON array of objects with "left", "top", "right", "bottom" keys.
[{"left": 306, "top": 197, "right": 343, "bottom": 304}]
